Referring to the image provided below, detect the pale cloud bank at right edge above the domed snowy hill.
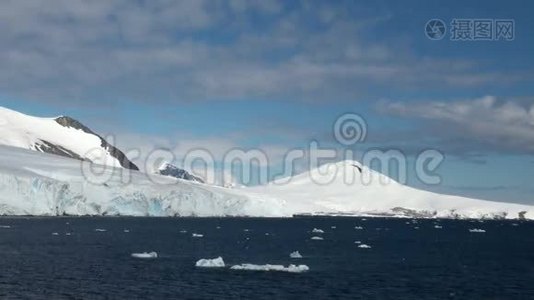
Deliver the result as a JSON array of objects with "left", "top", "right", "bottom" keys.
[{"left": 379, "top": 96, "right": 534, "bottom": 152}]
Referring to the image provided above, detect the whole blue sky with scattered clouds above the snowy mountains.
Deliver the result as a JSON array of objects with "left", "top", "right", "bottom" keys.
[{"left": 0, "top": 0, "right": 534, "bottom": 203}]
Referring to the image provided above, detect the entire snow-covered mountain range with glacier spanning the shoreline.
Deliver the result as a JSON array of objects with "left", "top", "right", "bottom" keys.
[{"left": 0, "top": 108, "right": 534, "bottom": 219}]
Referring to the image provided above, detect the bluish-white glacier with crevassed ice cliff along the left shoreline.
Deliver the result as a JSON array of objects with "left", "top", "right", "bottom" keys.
[{"left": 0, "top": 146, "right": 290, "bottom": 217}]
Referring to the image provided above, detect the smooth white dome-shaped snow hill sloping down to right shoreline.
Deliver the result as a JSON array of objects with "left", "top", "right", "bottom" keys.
[{"left": 247, "top": 161, "right": 534, "bottom": 219}]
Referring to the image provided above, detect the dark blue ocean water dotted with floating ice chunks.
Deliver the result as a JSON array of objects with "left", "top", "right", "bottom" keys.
[{"left": 0, "top": 217, "right": 534, "bottom": 299}]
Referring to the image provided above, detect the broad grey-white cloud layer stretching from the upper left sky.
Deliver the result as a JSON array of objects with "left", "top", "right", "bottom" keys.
[{"left": 0, "top": 0, "right": 521, "bottom": 102}]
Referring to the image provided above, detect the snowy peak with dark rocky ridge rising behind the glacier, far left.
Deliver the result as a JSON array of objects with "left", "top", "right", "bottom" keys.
[{"left": 0, "top": 107, "right": 139, "bottom": 170}]
